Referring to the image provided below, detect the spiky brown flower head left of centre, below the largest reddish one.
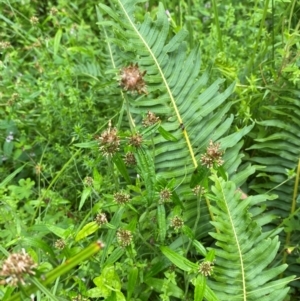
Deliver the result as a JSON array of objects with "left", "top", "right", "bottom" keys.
[{"left": 96, "top": 123, "right": 120, "bottom": 157}]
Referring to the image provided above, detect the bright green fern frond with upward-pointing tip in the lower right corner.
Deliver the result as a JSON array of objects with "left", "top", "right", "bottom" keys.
[{"left": 208, "top": 175, "right": 293, "bottom": 301}]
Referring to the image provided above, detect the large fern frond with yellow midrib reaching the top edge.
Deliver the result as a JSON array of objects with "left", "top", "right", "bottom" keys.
[{"left": 99, "top": 0, "right": 253, "bottom": 235}]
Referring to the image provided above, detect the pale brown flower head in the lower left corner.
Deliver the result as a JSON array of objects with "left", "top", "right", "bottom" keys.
[{"left": 0, "top": 249, "right": 37, "bottom": 286}]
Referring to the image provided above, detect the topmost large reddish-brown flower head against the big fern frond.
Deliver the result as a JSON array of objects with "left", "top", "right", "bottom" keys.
[{"left": 120, "top": 64, "right": 148, "bottom": 94}]
